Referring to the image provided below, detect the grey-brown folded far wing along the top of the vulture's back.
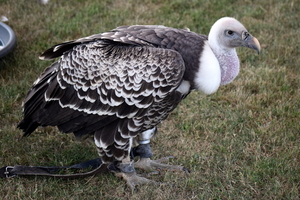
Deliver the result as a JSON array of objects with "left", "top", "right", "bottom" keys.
[{"left": 40, "top": 25, "right": 199, "bottom": 60}]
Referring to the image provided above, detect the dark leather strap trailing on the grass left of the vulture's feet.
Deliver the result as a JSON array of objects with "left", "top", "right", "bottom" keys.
[{"left": 0, "top": 158, "right": 109, "bottom": 179}]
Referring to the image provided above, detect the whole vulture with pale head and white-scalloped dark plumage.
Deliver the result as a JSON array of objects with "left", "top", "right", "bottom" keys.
[{"left": 18, "top": 17, "right": 260, "bottom": 188}]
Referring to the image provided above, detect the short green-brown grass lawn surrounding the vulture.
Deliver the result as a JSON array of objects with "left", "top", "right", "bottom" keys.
[{"left": 0, "top": 0, "right": 300, "bottom": 199}]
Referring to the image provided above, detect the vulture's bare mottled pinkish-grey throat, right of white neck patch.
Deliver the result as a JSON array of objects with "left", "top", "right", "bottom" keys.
[{"left": 211, "top": 43, "right": 240, "bottom": 85}]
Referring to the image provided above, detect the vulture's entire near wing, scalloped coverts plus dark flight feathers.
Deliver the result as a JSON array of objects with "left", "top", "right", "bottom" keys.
[{"left": 19, "top": 41, "right": 184, "bottom": 138}]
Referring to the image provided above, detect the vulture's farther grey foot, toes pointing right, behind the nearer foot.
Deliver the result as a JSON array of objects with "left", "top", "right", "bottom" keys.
[{"left": 134, "top": 156, "right": 190, "bottom": 173}]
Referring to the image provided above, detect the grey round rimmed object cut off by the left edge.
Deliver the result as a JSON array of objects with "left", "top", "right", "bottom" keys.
[{"left": 0, "top": 22, "right": 17, "bottom": 58}]
